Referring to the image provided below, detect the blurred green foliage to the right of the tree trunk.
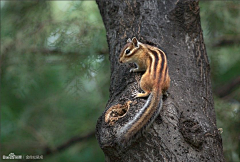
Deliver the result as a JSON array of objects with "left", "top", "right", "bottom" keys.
[{"left": 200, "top": 1, "right": 240, "bottom": 162}]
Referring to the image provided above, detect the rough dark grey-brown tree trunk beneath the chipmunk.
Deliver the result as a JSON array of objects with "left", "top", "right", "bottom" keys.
[{"left": 96, "top": 0, "right": 224, "bottom": 162}]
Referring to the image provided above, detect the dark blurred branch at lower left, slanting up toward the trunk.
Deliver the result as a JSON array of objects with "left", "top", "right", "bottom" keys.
[{"left": 43, "top": 131, "right": 95, "bottom": 155}]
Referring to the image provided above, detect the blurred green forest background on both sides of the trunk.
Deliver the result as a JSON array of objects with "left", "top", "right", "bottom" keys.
[{"left": 0, "top": 1, "right": 240, "bottom": 162}]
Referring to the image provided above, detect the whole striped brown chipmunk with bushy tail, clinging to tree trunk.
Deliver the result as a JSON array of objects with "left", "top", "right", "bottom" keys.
[{"left": 117, "top": 37, "right": 170, "bottom": 145}]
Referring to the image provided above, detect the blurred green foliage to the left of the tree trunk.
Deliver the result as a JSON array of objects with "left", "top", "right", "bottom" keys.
[{"left": 1, "top": 1, "right": 109, "bottom": 161}]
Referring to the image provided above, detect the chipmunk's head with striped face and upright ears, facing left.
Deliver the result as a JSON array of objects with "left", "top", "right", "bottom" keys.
[{"left": 119, "top": 37, "right": 142, "bottom": 63}]
